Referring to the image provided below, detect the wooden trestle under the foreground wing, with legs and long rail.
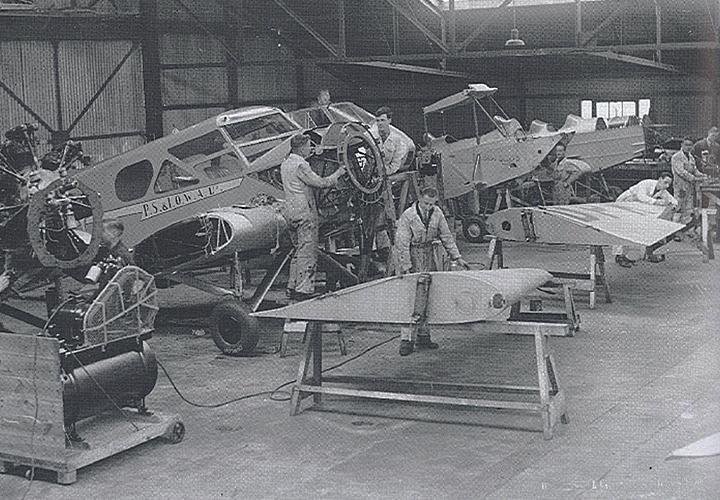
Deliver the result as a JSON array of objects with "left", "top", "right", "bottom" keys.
[{"left": 290, "top": 321, "right": 569, "bottom": 439}]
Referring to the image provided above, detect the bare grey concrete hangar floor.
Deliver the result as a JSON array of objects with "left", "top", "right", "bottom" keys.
[{"left": 0, "top": 238, "right": 720, "bottom": 499}]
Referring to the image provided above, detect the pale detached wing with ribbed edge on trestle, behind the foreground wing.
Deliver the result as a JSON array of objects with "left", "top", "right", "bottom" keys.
[{"left": 487, "top": 202, "right": 685, "bottom": 247}]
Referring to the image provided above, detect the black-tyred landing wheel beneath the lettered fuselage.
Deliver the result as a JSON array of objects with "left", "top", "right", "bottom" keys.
[{"left": 210, "top": 298, "right": 260, "bottom": 356}]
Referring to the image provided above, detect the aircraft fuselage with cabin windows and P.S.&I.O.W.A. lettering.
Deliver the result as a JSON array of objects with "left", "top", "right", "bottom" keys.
[{"left": 76, "top": 106, "right": 301, "bottom": 247}]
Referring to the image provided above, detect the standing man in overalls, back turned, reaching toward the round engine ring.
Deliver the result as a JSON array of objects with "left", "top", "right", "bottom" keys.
[{"left": 280, "top": 134, "right": 345, "bottom": 300}]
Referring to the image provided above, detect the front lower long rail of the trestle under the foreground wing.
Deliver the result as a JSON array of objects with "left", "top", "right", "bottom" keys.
[{"left": 299, "top": 384, "right": 541, "bottom": 411}]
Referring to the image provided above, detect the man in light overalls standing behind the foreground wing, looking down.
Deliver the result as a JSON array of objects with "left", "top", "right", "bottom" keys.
[{"left": 395, "top": 188, "right": 469, "bottom": 356}]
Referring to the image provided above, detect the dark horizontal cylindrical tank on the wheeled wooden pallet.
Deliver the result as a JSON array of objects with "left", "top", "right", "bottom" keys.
[{"left": 63, "top": 342, "right": 157, "bottom": 424}]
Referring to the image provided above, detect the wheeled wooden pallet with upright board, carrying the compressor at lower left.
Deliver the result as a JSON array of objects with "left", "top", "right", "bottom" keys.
[{"left": 0, "top": 333, "right": 185, "bottom": 484}]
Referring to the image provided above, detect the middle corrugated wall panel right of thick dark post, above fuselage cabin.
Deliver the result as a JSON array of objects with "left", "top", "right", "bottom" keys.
[{"left": 160, "top": 68, "right": 228, "bottom": 105}]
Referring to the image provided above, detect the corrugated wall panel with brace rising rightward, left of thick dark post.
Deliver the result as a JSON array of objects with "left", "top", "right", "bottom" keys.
[{"left": 60, "top": 41, "right": 145, "bottom": 136}]
